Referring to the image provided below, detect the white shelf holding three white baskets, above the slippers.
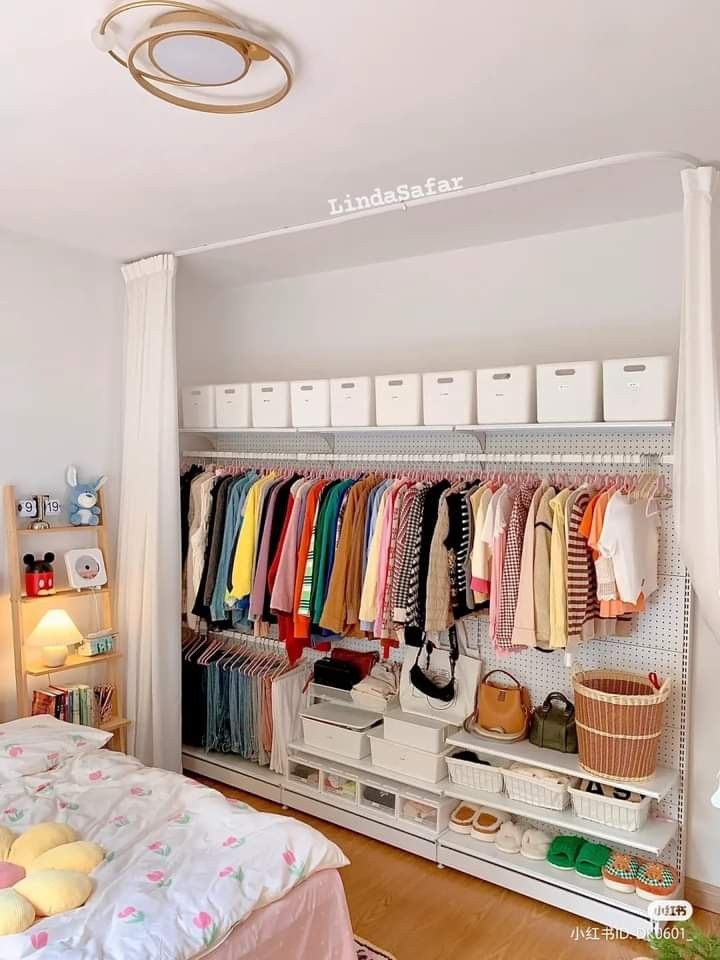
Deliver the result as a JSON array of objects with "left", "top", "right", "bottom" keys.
[{"left": 445, "top": 783, "right": 677, "bottom": 856}]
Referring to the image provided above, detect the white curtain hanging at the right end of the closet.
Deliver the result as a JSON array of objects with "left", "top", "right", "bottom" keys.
[{"left": 673, "top": 167, "right": 720, "bottom": 640}]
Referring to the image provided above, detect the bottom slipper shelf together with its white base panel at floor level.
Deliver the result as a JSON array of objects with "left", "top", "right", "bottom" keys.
[{"left": 438, "top": 830, "right": 652, "bottom": 936}]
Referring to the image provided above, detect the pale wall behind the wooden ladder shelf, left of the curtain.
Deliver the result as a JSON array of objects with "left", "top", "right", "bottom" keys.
[{"left": 0, "top": 233, "right": 123, "bottom": 720}]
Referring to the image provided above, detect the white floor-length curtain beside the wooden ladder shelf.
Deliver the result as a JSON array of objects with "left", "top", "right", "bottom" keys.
[{"left": 118, "top": 256, "right": 181, "bottom": 770}]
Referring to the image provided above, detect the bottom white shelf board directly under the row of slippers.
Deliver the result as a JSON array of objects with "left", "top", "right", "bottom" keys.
[{"left": 439, "top": 830, "right": 648, "bottom": 920}]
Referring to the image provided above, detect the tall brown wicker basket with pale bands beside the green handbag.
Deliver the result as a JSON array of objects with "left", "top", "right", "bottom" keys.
[{"left": 573, "top": 670, "right": 670, "bottom": 783}]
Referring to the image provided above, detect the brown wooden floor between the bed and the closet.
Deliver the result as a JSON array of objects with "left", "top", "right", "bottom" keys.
[{"left": 200, "top": 774, "right": 720, "bottom": 960}]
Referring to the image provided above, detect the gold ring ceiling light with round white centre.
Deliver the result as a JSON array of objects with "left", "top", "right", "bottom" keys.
[{"left": 93, "top": 0, "right": 293, "bottom": 113}]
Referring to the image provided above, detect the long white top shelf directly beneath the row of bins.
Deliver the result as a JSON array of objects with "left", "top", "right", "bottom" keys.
[{"left": 180, "top": 420, "right": 673, "bottom": 435}]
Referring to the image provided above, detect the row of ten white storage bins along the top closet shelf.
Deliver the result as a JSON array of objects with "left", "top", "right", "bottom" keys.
[{"left": 182, "top": 357, "right": 676, "bottom": 430}]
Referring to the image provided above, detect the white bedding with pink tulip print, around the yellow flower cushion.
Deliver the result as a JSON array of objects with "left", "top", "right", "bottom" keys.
[{"left": 0, "top": 717, "right": 348, "bottom": 960}]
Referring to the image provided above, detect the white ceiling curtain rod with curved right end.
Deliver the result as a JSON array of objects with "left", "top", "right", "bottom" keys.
[{"left": 175, "top": 150, "right": 703, "bottom": 257}]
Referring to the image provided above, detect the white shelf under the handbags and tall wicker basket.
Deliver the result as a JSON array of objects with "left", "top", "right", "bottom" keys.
[{"left": 447, "top": 730, "right": 678, "bottom": 800}]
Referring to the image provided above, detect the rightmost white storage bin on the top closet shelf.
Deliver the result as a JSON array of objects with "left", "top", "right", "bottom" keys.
[{"left": 603, "top": 357, "right": 677, "bottom": 421}]
